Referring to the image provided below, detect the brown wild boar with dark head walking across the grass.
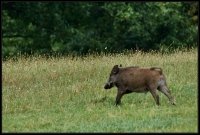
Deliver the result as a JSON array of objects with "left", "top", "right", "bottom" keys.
[{"left": 104, "top": 65, "right": 175, "bottom": 105}]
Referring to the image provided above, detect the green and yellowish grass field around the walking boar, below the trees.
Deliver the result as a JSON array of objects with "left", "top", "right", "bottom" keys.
[{"left": 2, "top": 49, "right": 198, "bottom": 132}]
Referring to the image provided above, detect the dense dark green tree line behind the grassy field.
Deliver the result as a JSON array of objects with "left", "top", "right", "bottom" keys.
[{"left": 2, "top": 2, "right": 198, "bottom": 57}]
